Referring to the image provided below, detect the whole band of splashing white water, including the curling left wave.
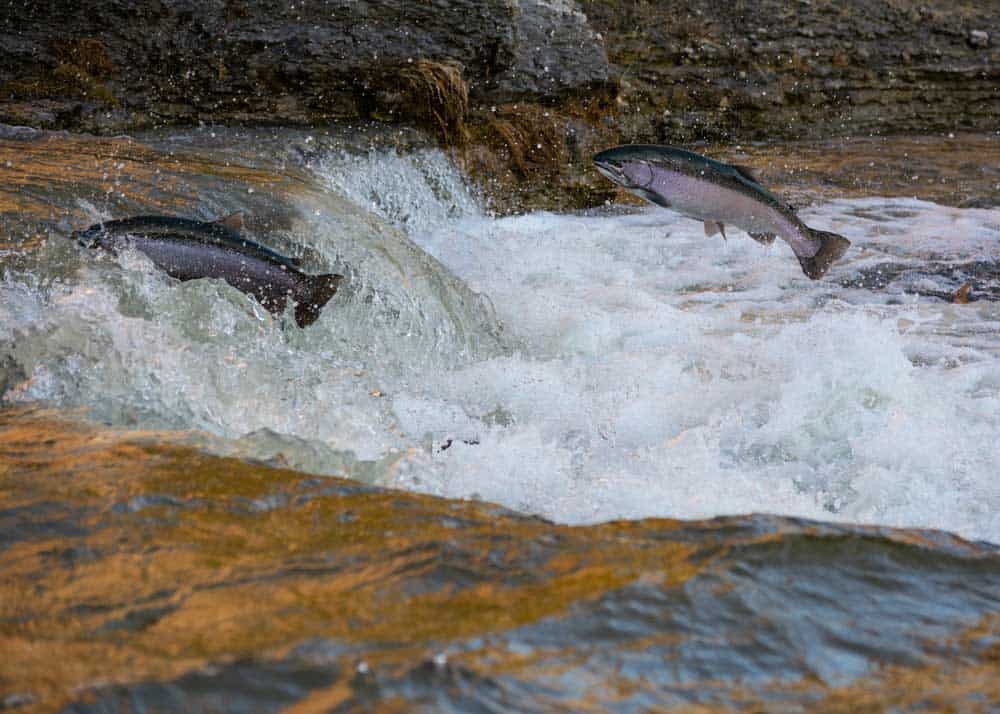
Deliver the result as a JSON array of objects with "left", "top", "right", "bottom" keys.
[{"left": 0, "top": 140, "right": 1000, "bottom": 541}]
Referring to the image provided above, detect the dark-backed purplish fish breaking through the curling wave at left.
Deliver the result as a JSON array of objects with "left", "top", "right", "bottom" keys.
[{"left": 73, "top": 216, "right": 343, "bottom": 327}]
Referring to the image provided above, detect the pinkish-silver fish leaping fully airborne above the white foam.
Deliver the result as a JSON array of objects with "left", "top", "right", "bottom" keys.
[{"left": 594, "top": 144, "right": 850, "bottom": 280}]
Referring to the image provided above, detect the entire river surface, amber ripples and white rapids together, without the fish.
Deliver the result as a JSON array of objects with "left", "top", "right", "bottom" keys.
[{"left": 0, "top": 128, "right": 1000, "bottom": 712}]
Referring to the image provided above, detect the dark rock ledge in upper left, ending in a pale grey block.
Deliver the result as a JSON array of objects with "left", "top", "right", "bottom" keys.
[{"left": 0, "top": 0, "right": 609, "bottom": 127}]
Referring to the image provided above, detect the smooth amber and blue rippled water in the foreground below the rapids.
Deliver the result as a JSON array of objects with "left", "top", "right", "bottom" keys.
[{"left": 0, "top": 409, "right": 1000, "bottom": 712}]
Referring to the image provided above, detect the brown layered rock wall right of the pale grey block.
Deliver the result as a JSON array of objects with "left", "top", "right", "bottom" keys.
[{"left": 582, "top": 0, "right": 1000, "bottom": 141}]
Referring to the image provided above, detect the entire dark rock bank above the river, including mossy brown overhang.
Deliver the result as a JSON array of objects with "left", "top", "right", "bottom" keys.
[{"left": 0, "top": 0, "right": 1000, "bottom": 211}]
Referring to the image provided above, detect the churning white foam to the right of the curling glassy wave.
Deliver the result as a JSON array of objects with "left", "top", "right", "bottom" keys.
[{"left": 382, "top": 174, "right": 1000, "bottom": 540}]
